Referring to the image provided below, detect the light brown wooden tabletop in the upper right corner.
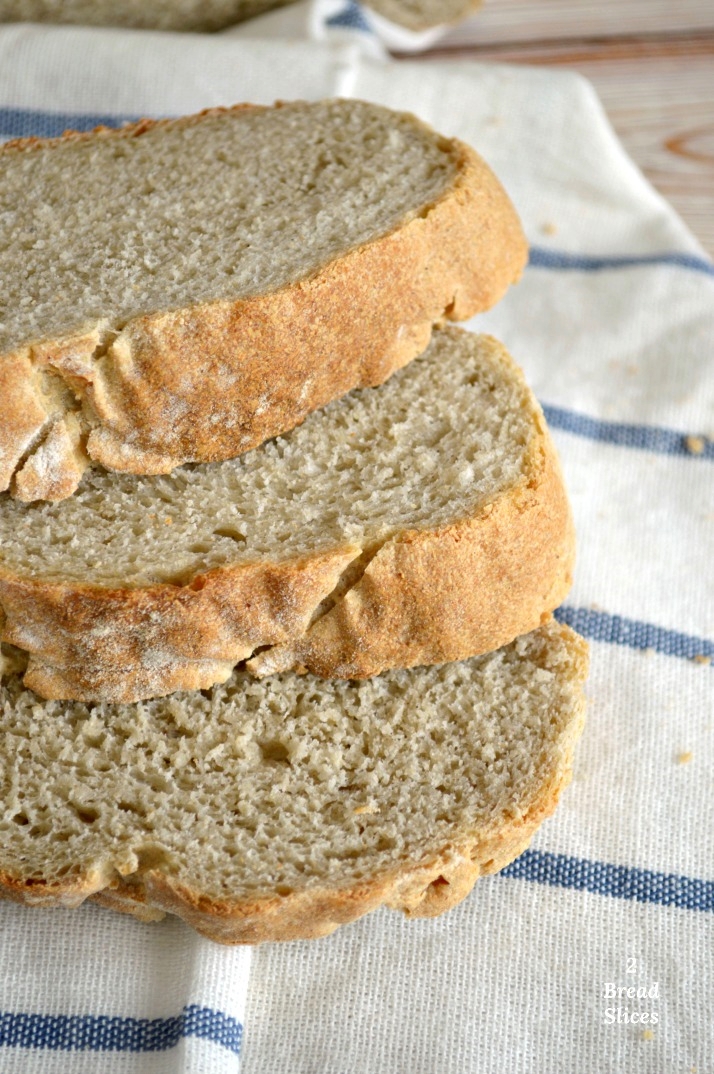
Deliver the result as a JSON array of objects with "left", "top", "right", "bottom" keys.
[{"left": 403, "top": 29, "right": 714, "bottom": 257}]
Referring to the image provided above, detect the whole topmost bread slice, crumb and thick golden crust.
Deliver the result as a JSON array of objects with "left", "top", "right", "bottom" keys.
[{"left": 0, "top": 100, "right": 526, "bottom": 502}]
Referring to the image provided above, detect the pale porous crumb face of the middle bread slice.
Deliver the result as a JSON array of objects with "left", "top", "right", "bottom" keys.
[{"left": 0, "top": 329, "right": 538, "bottom": 586}]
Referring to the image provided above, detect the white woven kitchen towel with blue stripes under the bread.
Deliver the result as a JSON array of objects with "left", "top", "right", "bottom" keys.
[{"left": 0, "top": 18, "right": 714, "bottom": 1074}]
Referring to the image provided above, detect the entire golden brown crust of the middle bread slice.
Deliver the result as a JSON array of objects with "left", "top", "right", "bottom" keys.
[{"left": 0, "top": 329, "right": 574, "bottom": 702}]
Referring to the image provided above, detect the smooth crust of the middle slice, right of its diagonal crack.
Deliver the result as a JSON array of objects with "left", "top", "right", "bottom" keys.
[{"left": 248, "top": 416, "right": 574, "bottom": 679}]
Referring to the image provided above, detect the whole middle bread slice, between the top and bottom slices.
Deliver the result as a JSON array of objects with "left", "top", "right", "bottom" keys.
[{"left": 0, "top": 328, "right": 573, "bottom": 701}]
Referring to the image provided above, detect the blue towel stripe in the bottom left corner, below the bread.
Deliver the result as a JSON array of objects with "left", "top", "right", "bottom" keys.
[{"left": 0, "top": 1004, "right": 243, "bottom": 1056}]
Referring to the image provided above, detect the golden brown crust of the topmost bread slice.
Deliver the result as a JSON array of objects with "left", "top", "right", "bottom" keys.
[{"left": 0, "top": 105, "right": 527, "bottom": 498}]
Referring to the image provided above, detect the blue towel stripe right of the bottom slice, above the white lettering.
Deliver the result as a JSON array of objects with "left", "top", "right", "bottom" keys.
[{"left": 500, "top": 850, "right": 714, "bottom": 913}]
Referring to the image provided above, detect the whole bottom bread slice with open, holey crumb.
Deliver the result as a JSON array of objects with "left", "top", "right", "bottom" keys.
[{"left": 0, "top": 622, "right": 587, "bottom": 943}]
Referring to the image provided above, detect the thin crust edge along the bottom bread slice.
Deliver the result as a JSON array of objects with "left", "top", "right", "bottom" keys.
[{"left": 0, "top": 624, "right": 588, "bottom": 944}]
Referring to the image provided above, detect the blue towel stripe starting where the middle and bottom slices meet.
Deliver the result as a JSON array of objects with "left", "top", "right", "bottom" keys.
[{"left": 555, "top": 605, "right": 714, "bottom": 662}]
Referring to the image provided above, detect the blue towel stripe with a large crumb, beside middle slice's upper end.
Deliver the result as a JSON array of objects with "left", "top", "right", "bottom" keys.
[{"left": 542, "top": 404, "right": 714, "bottom": 461}]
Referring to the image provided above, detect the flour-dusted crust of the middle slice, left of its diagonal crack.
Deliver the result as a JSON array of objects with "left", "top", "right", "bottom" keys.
[{"left": 0, "top": 545, "right": 359, "bottom": 701}]
